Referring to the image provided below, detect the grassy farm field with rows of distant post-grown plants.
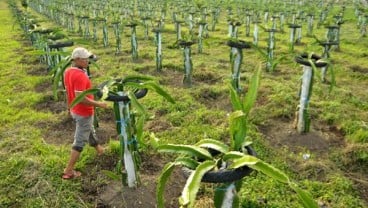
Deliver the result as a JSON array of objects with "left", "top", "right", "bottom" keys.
[{"left": 0, "top": 0, "right": 368, "bottom": 208}]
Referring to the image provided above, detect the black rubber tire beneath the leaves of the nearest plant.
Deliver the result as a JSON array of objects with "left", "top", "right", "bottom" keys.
[{"left": 202, "top": 146, "right": 257, "bottom": 183}]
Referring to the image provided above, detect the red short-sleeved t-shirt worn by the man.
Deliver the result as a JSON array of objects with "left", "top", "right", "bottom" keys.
[{"left": 64, "top": 67, "right": 94, "bottom": 116}]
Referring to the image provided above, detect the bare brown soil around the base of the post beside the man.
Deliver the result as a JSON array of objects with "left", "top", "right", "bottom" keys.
[{"left": 82, "top": 153, "right": 185, "bottom": 208}]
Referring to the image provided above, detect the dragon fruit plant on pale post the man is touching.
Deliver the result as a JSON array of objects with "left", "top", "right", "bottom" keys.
[{"left": 70, "top": 76, "right": 175, "bottom": 187}]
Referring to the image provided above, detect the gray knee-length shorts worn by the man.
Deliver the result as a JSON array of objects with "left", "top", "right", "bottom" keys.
[{"left": 71, "top": 113, "right": 98, "bottom": 152}]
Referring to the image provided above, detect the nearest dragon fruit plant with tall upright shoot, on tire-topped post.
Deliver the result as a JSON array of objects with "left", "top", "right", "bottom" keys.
[{"left": 156, "top": 68, "right": 318, "bottom": 208}]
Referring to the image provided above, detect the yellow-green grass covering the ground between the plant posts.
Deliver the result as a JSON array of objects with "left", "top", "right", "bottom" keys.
[{"left": 0, "top": 2, "right": 368, "bottom": 207}]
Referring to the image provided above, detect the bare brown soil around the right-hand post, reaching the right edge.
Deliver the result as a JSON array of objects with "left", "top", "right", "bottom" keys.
[{"left": 259, "top": 118, "right": 368, "bottom": 204}]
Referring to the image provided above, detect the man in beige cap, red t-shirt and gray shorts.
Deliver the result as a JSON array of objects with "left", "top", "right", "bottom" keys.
[{"left": 62, "top": 47, "right": 108, "bottom": 179}]
